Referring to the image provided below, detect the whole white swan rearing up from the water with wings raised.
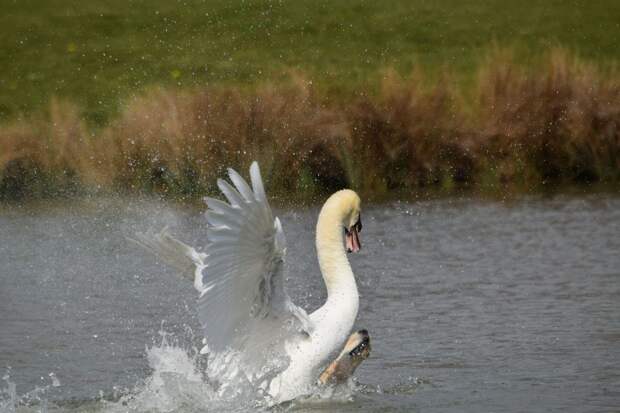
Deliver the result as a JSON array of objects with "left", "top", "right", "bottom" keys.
[{"left": 131, "top": 162, "right": 362, "bottom": 403}]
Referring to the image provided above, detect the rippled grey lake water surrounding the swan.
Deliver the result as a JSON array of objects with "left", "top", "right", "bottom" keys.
[{"left": 0, "top": 196, "right": 620, "bottom": 412}]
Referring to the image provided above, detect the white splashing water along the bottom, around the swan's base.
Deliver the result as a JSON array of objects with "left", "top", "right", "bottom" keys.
[{"left": 0, "top": 331, "right": 358, "bottom": 413}]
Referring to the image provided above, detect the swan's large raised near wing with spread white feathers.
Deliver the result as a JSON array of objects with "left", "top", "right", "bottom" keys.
[{"left": 198, "top": 162, "right": 312, "bottom": 352}]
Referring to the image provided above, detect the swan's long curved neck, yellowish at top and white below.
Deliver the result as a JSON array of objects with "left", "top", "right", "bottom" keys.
[{"left": 316, "top": 202, "right": 359, "bottom": 300}]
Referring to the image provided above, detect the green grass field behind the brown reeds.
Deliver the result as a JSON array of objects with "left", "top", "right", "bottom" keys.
[{"left": 0, "top": 0, "right": 620, "bottom": 125}]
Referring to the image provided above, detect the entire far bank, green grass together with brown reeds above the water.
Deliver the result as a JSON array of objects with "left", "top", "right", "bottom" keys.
[{"left": 0, "top": 0, "right": 620, "bottom": 200}]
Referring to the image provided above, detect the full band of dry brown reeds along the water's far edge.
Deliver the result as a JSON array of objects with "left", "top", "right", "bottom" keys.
[{"left": 0, "top": 51, "right": 620, "bottom": 199}]
